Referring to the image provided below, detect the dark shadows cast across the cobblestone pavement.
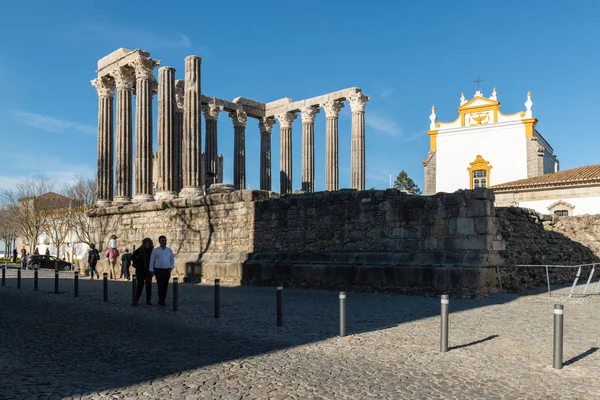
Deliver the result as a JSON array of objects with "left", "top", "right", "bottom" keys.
[{"left": 0, "top": 278, "right": 597, "bottom": 398}]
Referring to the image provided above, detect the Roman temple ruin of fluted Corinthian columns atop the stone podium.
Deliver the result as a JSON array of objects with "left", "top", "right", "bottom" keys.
[{"left": 92, "top": 48, "right": 369, "bottom": 206}]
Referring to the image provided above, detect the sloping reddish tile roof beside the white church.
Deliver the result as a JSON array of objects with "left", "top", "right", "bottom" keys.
[{"left": 490, "top": 164, "right": 600, "bottom": 191}]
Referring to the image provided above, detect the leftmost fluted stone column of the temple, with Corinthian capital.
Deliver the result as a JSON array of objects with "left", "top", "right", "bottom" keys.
[{"left": 92, "top": 76, "right": 115, "bottom": 206}]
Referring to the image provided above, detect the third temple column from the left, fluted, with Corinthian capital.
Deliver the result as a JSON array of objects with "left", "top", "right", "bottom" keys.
[{"left": 133, "top": 58, "right": 158, "bottom": 202}]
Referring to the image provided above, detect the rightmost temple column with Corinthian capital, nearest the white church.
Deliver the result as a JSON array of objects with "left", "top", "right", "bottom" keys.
[{"left": 348, "top": 93, "right": 369, "bottom": 190}]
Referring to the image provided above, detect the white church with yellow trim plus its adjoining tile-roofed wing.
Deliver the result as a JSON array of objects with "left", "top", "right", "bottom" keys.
[{"left": 423, "top": 88, "right": 600, "bottom": 216}]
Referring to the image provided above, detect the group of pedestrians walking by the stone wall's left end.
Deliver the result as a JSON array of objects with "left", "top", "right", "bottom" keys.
[{"left": 88, "top": 235, "right": 175, "bottom": 306}]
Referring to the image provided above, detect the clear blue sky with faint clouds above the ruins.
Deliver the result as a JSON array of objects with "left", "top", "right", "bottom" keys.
[{"left": 0, "top": 0, "right": 600, "bottom": 194}]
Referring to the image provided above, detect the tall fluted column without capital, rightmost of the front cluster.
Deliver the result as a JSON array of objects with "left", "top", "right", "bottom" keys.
[{"left": 179, "top": 56, "right": 202, "bottom": 197}]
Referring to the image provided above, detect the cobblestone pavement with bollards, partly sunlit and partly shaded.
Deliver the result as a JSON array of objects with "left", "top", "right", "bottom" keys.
[{"left": 0, "top": 271, "right": 600, "bottom": 399}]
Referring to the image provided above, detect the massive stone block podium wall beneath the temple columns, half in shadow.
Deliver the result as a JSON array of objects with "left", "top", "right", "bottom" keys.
[{"left": 89, "top": 188, "right": 501, "bottom": 292}]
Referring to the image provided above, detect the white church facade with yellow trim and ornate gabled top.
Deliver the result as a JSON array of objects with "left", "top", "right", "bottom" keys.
[{"left": 423, "top": 89, "right": 559, "bottom": 195}]
